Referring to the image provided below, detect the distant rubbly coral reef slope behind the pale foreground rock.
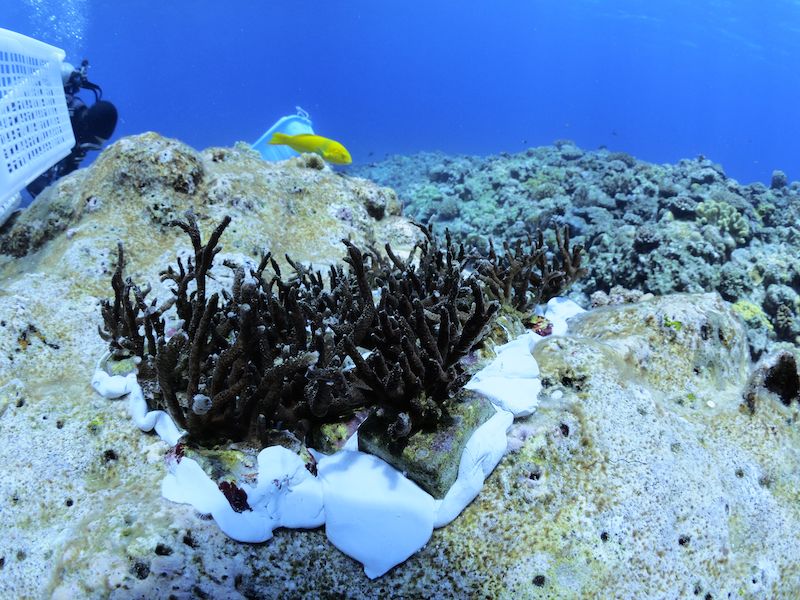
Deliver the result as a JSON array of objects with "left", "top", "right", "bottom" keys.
[{"left": 351, "top": 146, "right": 800, "bottom": 357}]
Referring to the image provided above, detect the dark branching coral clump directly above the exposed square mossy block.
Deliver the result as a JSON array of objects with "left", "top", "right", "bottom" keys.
[{"left": 345, "top": 227, "right": 499, "bottom": 439}]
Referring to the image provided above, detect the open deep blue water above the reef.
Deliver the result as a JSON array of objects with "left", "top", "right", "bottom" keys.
[{"left": 6, "top": 0, "right": 800, "bottom": 182}]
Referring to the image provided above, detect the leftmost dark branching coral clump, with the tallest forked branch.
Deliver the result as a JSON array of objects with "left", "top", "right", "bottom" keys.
[{"left": 101, "top": 213, "right": 315, "bottom": 442}]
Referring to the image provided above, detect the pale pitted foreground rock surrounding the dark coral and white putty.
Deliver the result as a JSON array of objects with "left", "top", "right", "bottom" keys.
[{"left": 0, "top": 134, "right": 800, "bottom": 598}]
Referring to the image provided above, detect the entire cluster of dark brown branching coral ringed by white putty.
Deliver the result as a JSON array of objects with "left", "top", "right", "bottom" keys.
[{"left": 99, "top": 212, "right": 583, "bottom": 474}]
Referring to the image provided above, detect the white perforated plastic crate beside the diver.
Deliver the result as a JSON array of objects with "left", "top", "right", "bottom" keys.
[{"left": 0, "top": 29, "right": 75, "bottom": 225}]
